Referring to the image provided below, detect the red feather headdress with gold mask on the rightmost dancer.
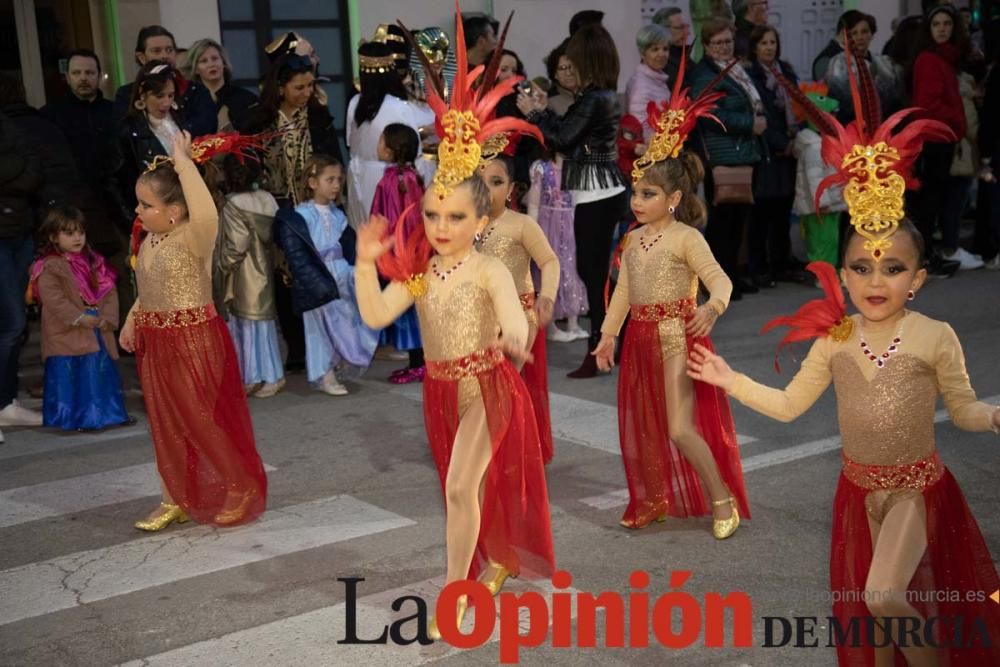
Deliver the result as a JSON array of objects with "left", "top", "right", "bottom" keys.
[{"left": 771, "top": 34, "right": 955, "bottom": 261}]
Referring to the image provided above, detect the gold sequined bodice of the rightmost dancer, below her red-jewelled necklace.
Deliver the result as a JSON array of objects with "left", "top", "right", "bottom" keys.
[{"left": 830, "top": 349, "right": 938, "bottom": 465}]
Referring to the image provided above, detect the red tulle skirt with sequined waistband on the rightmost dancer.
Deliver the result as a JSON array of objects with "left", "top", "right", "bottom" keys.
[{"left": 830, "top": 453, "right": 1000, "bottom": 667}]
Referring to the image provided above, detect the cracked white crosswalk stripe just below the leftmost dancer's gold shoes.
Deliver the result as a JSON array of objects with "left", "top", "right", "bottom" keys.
[{"left": 0, "top": 495, "right": 414, "bottom": 625}]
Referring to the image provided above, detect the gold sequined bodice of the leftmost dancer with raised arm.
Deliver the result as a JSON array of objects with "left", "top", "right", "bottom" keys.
[{"left": 135, "top": 231, "right": 212, "bottom": 311}]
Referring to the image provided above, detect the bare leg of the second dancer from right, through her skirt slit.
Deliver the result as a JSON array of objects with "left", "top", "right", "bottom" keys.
[{"left": 663, "top": 354, "right": 732, "bottom": 519}]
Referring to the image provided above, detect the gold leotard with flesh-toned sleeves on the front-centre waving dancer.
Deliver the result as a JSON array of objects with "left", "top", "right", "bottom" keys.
[{"left": 354, "top": 251, "right": 528, "bottom": 414}]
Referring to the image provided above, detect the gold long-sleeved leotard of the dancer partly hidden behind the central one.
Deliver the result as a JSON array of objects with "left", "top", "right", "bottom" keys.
[{"left": 479, "top": 209, "right": 559, "bottom": 327}]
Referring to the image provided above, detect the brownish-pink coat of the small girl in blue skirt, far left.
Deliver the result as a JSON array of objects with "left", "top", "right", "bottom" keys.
[{"left": 38, "top": 257, "right": 118, "bottom": 361}]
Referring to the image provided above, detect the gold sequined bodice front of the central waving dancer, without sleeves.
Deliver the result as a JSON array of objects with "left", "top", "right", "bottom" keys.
[{"left": 416, "top": 276, "right": 500, "bottom": 361}]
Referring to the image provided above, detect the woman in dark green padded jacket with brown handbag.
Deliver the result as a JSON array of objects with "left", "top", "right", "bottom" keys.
[{"left": 690, "top": 19, "right": 767, "bottom": 300}]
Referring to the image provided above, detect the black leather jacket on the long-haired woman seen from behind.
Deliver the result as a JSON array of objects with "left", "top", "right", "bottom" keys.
[{"left": 528, "top": 86, "right": 625, "bottom": 190}]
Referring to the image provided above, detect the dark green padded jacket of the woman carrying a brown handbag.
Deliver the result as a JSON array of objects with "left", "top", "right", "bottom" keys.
[{"left": 690, "top": 58, "right": 763, "bottom": 167}]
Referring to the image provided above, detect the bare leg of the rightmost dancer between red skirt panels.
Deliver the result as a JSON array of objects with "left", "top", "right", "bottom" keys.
[{"left": 865, "top": 491, "right": 939, "bottom": 667}]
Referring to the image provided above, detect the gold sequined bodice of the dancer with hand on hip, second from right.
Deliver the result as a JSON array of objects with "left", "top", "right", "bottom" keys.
[{"left": 622, "top": 234, "right": 698, "bottom": 305}]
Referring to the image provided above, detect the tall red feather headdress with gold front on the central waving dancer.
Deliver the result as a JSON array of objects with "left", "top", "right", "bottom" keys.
[{"left": 399, "top": 0, "right": 543, "bottom": 198}]
